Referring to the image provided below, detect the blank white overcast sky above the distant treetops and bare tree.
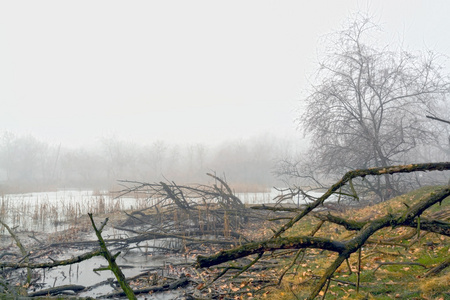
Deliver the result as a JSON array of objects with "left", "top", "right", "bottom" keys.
[{"left": 0, "top": 0, "right": 450, "bottom": 146}]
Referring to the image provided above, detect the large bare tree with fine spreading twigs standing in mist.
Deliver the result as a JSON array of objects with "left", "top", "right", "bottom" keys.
[{"left": 298, "top": 17, "right": 449, "bottom": 199}]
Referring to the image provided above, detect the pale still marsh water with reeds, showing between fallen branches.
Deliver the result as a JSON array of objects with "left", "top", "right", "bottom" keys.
[{"left": 0, "top": 190, "right": 302, "bottom": 299}]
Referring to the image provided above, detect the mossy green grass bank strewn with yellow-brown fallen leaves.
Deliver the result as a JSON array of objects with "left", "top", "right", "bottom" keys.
[{"left": 262, "top": 186, "right": 450, "bottom": 300}]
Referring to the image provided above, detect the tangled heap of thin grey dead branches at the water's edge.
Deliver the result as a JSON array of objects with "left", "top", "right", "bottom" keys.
[{"left": 115, "top": 173, "right": 256, "bottom": 235}]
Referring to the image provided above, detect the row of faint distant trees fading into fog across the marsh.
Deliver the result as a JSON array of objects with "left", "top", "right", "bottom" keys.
[{"left": 0, "top": 132, "right": 302, "bottom": 193}]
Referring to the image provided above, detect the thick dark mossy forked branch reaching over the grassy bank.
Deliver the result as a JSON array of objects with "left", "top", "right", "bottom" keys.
[{"left": 196, "top": 162, "right": 450, "bottom": 299}]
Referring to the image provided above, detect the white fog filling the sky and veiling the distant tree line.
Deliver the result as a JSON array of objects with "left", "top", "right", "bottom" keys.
[{"left": 0, "top": 0, "right": 450, "bottom": 189}]
